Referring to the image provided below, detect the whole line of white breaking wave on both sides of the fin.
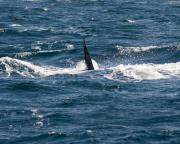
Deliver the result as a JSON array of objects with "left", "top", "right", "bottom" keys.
[{"left": 0, "top": 57, "right": 180, "bottom": 80}]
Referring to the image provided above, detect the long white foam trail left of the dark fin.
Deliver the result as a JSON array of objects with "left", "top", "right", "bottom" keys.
[{"left": 0, "top": 57, "right": 95, "bottom": 77}]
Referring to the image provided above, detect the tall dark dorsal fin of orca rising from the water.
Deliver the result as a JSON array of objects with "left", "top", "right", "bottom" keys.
[{"left": 83, "top": 38, "right": 94, "bottom": 70}]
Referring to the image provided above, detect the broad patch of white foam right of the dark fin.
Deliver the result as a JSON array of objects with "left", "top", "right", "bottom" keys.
[{"left": 104, "top": 62, "right": 180, "bottom": 80}]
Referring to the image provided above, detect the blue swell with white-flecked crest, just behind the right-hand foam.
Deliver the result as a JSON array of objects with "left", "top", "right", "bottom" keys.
[{"left": 115, "top": 44, "right": 180, "bottom": 64}]
